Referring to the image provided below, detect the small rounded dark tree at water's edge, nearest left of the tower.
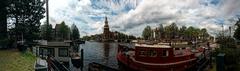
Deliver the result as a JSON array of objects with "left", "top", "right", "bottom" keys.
[{"left": 71, "top": 24, "right": 80, "bottom": 40}]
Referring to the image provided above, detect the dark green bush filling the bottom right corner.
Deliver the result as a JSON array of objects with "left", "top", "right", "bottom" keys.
[{"left": 215, "top": 33, "right": 240, "bottom": 71}]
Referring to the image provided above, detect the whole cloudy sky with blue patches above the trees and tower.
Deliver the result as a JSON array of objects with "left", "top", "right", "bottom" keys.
[{"left": 41, "top": 0, "right": 240, "bottom": 36}]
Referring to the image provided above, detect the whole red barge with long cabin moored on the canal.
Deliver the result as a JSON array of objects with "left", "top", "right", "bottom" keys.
[{"left": 117, "top": 43, "right": 204, "bottom": 71}]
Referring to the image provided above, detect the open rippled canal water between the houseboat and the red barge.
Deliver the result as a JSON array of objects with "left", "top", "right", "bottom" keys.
[{"left": 80, "top": 41, "right": 118, "bottom": 71}]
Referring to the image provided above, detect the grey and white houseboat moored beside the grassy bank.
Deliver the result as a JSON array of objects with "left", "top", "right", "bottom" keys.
[{"left": 33, "top": 40, "right": 83, "bottom": 71}]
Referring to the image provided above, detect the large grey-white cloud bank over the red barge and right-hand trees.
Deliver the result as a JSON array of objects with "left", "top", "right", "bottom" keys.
[{"left": 111, "top": 0, "right": 240, "bottom": 36}]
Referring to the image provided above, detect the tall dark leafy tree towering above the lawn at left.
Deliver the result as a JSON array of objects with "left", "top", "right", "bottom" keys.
[{"left": 7, "top": 0, "right": 45, "bottom": 46}]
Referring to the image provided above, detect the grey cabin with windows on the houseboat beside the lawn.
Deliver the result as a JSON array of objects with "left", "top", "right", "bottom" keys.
[{"left": 35, "top": 41, "right": 71, "bottom": 62}]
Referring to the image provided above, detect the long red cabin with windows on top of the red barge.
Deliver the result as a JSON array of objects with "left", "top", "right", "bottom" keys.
[{"left": 135, "top": 44, "right": 194, "bottom": 63}]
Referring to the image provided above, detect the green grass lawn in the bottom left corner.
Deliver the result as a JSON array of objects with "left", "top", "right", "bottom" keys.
[{"left": 0, "top": 49, "right": 36, "bottom": 71}]
